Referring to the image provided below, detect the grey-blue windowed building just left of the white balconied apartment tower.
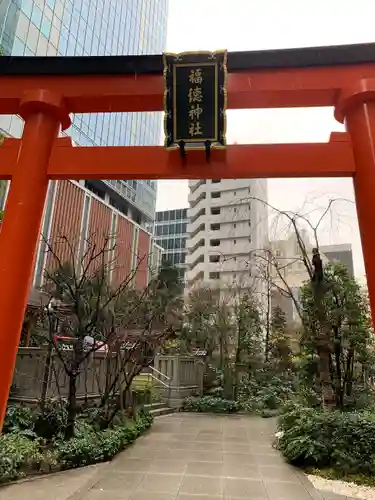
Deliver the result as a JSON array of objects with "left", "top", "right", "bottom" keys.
[{"left": 155, "top": 208, "right": 188, "bottom": 281}]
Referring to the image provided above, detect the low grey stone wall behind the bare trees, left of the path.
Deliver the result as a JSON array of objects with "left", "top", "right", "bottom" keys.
[{"left": 13, "top": 347, "right": 204, "bottom": 408}]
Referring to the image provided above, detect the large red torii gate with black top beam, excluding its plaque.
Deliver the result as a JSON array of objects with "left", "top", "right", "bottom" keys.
[{"left": 0, "top": 44, "right": 375, "bottom": 428}]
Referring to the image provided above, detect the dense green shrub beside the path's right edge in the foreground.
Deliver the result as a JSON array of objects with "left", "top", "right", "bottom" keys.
[{"left": 278, "top": 403, "right": 375, "bottom": 475}]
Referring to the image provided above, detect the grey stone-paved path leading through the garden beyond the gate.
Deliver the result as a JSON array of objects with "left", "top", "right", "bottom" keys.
[{"left": 0, "top": 414, "right": 356, "bottom": 500}]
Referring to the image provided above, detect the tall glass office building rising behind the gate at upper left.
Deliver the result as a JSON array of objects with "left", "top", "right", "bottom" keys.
[{"left": 0, "top": 0, "right": 169, "bottom": 224}]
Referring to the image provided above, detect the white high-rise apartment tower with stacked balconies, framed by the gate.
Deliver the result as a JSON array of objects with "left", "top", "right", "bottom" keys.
[{"left": 186, "top": 179, "right": 268, "bottom": 293}]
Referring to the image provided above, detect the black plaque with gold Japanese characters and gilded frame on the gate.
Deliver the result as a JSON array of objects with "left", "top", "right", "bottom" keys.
[{"left": 164, "top": 51, "right": 227, "bottom": 149}]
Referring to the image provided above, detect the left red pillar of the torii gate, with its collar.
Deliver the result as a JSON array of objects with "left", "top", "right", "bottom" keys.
[{"left": 0, "top": 90, "right": 70, "bottom": 428}]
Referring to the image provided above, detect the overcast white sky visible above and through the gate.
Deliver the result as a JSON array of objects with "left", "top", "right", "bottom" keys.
[{"left": 157, "top": 0, "right": 375, "bottom": 278}]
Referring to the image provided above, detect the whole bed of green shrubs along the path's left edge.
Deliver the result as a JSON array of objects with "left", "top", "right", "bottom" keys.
[{"left": 0, "top": 407, "right": 153, "bottom": 482}]
